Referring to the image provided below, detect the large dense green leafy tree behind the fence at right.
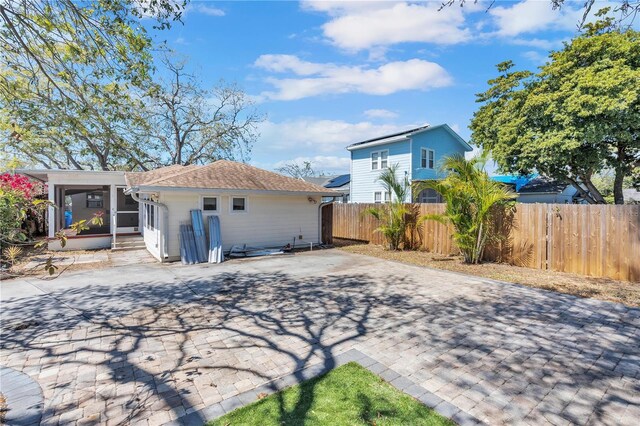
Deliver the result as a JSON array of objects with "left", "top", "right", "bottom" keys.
[{"left": 471, "top": 12, "right": 640, "bottom": 204}]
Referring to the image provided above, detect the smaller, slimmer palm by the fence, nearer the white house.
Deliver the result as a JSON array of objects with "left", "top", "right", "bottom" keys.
[{"left": 363, "top": 164, "right": 411, "bottom": 250}]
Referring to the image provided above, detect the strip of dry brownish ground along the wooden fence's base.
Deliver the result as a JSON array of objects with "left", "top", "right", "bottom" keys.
[{"left": 336, "top": 240, "right": 640, "bottom": 307}]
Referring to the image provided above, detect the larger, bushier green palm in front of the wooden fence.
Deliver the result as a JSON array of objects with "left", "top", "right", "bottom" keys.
[{"left": 416, "top": 155, "right": 515, "bottom": 263}]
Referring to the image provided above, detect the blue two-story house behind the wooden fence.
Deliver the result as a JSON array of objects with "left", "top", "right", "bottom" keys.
[{"left": 347, "top": 124, "right": 472, "bottom": 203}]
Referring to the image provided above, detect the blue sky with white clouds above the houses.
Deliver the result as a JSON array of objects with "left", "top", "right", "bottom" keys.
[{"left": 144, "top": 0, "right": 607, "bottom": 173}]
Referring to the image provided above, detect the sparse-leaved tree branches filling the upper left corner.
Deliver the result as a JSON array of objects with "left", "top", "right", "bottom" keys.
[{"left": 0, "top": 0, "right": 184, "bottom": 170}]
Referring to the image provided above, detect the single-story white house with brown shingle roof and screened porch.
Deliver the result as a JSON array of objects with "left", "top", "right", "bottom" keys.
[{"left": 18, "top": 160, "right": 341, "bottom": 262}]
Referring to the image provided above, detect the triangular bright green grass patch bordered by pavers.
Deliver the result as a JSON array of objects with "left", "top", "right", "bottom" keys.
[{"left": 207, "top": 362, "right": 454, "bottom": 426}]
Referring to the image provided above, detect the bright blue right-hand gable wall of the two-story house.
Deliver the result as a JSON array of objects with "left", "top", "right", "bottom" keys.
[{"left": 411, "top": 127, "right": 466, "bottom": 180}]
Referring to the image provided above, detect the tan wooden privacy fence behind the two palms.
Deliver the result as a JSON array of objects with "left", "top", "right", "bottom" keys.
[{"left": 333, "top": 204, "right": 640, "bottom": 281}]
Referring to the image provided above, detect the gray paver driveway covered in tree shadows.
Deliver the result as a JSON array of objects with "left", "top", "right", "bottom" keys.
[{"left": 0, "top": 250, "right": 640, "bottom": 425}]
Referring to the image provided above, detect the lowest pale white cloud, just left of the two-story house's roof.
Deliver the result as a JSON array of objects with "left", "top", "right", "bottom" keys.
[{"left": 255, "top": 119, "right": 417, "bottom": 153}]
